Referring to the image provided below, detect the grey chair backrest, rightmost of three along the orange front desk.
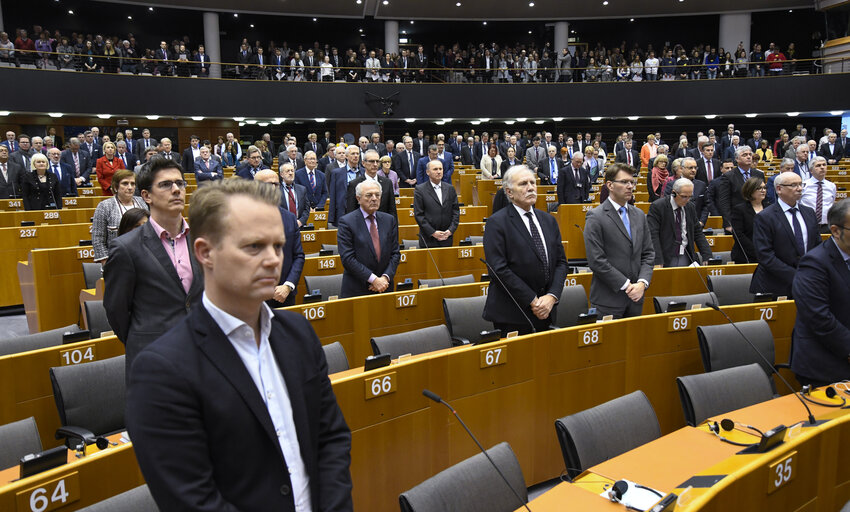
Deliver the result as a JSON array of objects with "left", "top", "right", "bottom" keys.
[{"left": 676, "top": 363, "right": 773, "bottom": 426}]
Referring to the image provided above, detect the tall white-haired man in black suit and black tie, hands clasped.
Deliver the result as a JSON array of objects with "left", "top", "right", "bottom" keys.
[{"left": 483, "top": 166, "right": 567, "bottom": 334}]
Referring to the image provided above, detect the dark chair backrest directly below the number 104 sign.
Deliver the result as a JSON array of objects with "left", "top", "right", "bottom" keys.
[{"left": 50, "top": 356, "right": 126, "bottom": 435}]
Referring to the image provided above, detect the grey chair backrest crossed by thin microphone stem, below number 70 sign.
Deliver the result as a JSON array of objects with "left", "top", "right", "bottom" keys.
[{"left": 697, "top": 320, "right": 776, "bottom": 375}]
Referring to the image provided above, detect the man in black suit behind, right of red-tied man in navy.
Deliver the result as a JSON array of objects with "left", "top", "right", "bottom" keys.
[{"left": 413, "top": 160, "right": 460, "bottom": 248}]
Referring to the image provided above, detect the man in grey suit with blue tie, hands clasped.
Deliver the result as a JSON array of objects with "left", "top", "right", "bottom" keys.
[{"left": 584, "top": 163, "right": 655, "bottom": 318}]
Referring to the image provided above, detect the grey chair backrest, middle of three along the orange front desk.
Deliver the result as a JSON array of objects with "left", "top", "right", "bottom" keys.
[{"left": 555, "top": 390, "right": 661, "bottom": 478}]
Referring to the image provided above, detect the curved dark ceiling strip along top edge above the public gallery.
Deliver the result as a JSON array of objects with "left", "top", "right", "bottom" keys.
[{"left": 101, "top": 0, "right": 813, "bottom": 21}]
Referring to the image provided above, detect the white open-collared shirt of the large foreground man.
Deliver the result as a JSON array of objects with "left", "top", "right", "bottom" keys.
[{"left": 202, "top": 292, "right": 313, "bottom": 512}]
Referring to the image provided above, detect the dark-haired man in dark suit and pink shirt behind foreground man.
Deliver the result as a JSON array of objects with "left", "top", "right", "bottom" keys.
[{"left": 103, "top": 158, "right": 203, "bottom": 374}]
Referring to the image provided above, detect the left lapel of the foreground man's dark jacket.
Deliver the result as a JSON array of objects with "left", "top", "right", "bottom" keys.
[{"left": 190, "top": 305, "right": 289, "bottom": 459}]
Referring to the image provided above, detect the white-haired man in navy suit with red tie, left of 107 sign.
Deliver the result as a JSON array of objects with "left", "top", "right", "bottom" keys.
[{"left": 337, "top": 180, "right": 400, "bottom": 298}]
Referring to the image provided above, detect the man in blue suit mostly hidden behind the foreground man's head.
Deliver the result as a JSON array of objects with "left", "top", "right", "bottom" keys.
[{"left": 254, "top": 169, "right": 304, "bottom": 308}]
